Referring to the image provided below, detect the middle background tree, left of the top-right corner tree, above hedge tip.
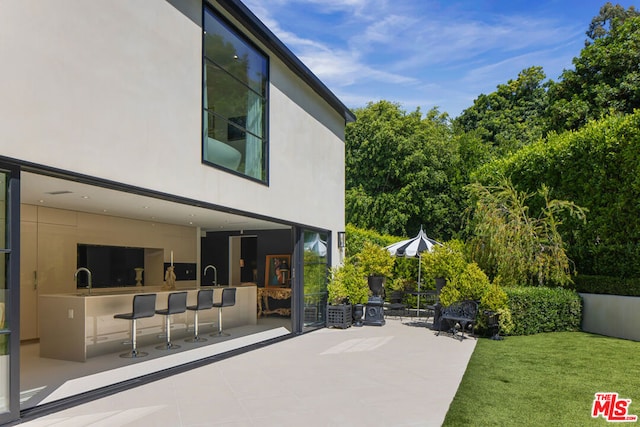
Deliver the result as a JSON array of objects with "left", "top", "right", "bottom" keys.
[{"left": 455, "top": 67, "right": 549, "bottom": 158}]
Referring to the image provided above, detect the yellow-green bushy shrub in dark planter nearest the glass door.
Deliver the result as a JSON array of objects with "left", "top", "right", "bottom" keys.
[{"left": 327, "top": 259, "right": 369, "bottom": 305}]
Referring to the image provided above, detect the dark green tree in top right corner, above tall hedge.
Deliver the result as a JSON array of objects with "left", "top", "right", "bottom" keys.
[{"left": 547, "top": 16, "right": 640, "bottom": 132}]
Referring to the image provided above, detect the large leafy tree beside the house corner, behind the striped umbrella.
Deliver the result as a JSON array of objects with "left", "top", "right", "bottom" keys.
[{"left": 345, "top": 101, "right": 461, "bottom": 238}]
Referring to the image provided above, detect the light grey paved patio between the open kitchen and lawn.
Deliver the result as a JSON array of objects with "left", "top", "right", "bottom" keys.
[{"left": 21, "top": 318, "right": 476, "bottom": 427}]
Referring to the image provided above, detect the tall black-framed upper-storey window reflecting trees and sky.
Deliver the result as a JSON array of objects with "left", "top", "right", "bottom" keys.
[{"left": 202, "top": 9, "right": 268, "bottom": 182}]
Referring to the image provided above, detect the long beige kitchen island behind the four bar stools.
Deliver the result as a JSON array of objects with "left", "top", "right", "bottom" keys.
[{"left": 38, "top": 286, "right": 256, "bottom": 362}]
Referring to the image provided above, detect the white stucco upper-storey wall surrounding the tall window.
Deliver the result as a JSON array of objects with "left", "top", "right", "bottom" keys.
[{"left": 0, "top": 0, "right": 344, "bottom": 259}]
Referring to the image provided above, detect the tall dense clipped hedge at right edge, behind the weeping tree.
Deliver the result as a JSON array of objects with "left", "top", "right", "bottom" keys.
[{"left": 474, "top": 110, "right": 640, "bottom": 277}]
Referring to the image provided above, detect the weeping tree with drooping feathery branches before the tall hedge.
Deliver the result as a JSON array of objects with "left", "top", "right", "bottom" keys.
[{"left": 468, "top": 180, "right": 585, "bottom": 286}]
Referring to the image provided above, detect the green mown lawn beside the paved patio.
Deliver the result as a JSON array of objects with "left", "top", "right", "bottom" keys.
[{"left": 443, "top": 332, "right": 640, "bottom": 427}]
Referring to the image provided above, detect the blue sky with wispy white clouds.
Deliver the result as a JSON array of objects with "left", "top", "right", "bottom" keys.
[{"left": 244, "top": 0, "right": 639, "bottom": 117}]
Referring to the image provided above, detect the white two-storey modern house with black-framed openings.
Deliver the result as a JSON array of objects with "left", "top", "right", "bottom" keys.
[{"left": 0, "top": 0, "right": 355, "bottom": 424}]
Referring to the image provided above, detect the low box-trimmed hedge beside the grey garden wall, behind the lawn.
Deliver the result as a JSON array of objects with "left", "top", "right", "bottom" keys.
[{"left": 504, "top": 286, "right": 582, "bottom": 335}]
